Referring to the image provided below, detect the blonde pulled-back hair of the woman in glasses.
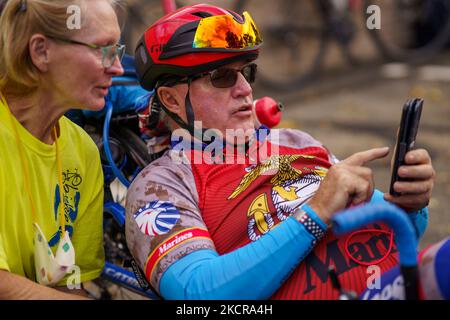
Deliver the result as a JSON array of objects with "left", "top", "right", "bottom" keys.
[{"left": 0, "top": 0, "right": 118, "bottom": 95}]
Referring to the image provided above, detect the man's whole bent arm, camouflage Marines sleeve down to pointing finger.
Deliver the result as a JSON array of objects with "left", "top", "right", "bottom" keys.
[{"left": 126, "top": 149, "right": 388, "bottom": 299}]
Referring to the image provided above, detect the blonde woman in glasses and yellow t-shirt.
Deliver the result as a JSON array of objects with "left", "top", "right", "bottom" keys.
[{"left": 0, "top": 0, "right": 124, "bottom": 299}]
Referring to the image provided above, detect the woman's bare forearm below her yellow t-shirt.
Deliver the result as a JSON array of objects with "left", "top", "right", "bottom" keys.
[{"left": 0, "top": 270, "right": 86, "bottom": 300}]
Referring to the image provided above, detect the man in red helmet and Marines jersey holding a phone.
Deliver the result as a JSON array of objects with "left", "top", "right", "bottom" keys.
[{"left": 126, "top": 5, "right": 442, "bottom": 299}]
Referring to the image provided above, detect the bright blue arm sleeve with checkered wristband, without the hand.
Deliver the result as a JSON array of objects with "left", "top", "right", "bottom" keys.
[{"left": 159, "top": 205, "right": 326, "bottom": 300}]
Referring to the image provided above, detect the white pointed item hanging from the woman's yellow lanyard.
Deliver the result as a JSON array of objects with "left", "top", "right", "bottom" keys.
[{"left": 33, "top": 223, "right": 75, "bottom": 286}]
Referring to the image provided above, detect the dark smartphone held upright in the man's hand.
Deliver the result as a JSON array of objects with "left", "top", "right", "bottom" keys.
[{"left": 389, "top": 98, "right": 423, "bottom": 196}]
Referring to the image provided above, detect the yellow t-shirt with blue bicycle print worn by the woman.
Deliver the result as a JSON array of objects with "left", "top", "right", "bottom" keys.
[{"left": 0, "top": 100, "right": 104, "bottom": 285}]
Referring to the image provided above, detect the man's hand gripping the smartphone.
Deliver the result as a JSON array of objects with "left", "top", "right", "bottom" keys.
[{"left": 384, "top": 149, "right": 436, "bottom": 212}]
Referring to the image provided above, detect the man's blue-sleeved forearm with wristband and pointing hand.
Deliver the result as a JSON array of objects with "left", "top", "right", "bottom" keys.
[{"left": 160, "top": 148, "right": 398, "bottom": 299}]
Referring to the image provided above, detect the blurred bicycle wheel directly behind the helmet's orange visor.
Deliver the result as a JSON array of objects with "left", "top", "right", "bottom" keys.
[{"left": 233, "top": 0, "right": 329, "bottom": 91}]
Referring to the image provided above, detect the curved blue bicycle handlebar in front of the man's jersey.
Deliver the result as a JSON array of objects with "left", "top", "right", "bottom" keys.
[{"left": 332, "top": 203, "right": 418, "bottom": 267}]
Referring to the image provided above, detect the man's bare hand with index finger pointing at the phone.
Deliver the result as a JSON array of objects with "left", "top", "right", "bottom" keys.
[{"left": 308, "top": 147, "right": 389, "bottom": 224}]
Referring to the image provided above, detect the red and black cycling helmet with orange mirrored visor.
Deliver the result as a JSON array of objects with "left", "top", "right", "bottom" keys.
[{"left": 135, "top": 4, "right": 262, "bottom": 90}]
